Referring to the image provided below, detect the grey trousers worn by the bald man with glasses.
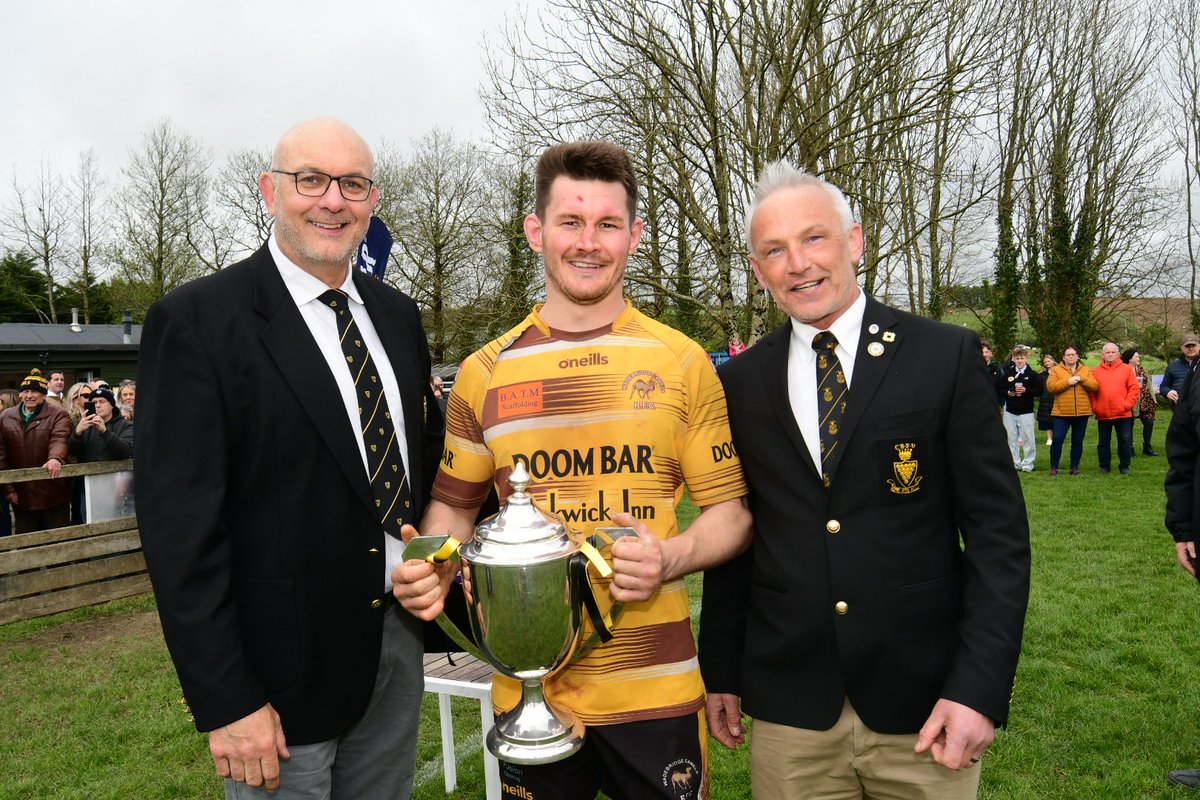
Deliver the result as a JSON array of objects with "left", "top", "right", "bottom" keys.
[{"left": 224, "top": 606, "right": 425, "bottom": 800}]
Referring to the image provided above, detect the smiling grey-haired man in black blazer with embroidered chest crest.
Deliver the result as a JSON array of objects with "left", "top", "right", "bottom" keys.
[{"left": 700, "top": 163, "right": 1030, "bottom": 800}]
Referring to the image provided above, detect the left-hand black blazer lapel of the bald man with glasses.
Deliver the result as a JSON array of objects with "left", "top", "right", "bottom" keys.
[{"left": 251, "top": 246, "right": 376, "bottom": 512}]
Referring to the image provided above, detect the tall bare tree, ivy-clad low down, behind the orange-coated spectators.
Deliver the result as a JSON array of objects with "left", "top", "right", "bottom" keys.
[{"left": 1025, "top": 0, "right": 1165, "bottom": 351}]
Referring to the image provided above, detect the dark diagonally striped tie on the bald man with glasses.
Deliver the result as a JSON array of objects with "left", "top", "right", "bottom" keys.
[{"left": 319, "top": 289, "right": 413, "bottom": 539}]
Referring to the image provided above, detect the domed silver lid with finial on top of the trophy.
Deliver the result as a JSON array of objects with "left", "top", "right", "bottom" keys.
[{"left": 462, "top": 461, "right": 580, "bottom": 564}]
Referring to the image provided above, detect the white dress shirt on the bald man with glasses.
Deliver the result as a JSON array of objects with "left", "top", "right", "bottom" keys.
[{"left": 266, "top": 233, "right": 412, "bottom": 591}]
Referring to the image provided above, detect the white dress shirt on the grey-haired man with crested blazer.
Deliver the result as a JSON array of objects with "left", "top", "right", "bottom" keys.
[{"left": 787, "top": 289, "right": 866, "bottom": 473}]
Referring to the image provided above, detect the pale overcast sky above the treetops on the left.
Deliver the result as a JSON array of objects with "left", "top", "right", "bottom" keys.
[{"left": 0, "top": 0, "right": 528, "bottom": 204}]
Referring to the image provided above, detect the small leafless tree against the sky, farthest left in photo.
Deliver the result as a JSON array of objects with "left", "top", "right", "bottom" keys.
[{"left": 4, "top": 158, "right": 71, "bottom": 323}]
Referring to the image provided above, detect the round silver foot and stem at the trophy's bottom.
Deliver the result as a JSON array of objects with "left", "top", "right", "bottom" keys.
[{"left": 487, "top": 678, "right": 583, "bottom": 764}]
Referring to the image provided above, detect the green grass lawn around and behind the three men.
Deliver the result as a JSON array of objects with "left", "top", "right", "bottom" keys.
[{"left": 0, "top": 413, "right": 1200, "bottom": 800}]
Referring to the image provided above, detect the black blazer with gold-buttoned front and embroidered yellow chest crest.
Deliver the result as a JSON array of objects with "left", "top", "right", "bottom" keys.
[{"left": 700, "top": 299, "right": 1030, "bottom": 734}]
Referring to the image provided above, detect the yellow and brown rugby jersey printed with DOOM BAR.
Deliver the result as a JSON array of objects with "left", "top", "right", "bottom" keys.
[{"left": 433, "top": 301, "right": 746, "bottom": 724}]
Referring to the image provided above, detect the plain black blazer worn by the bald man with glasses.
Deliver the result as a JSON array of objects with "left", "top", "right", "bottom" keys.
[{"left": 134, "top": 246, "right": 440, "bottom": 744}]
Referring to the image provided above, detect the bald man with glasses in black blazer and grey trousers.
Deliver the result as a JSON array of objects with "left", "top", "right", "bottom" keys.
[{"left": 134, "top": 119, "right": 442, "bottom": 800}]
